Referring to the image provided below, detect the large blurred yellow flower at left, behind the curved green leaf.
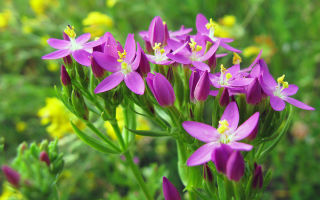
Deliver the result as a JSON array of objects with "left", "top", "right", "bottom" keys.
[{"left": 38, "top": 98, "right": 85, "bottom": 138}]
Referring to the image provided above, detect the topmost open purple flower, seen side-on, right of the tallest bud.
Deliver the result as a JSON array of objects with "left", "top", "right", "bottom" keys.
[{"left": 196, "top": 13, "right": 241, "bottom": 53}]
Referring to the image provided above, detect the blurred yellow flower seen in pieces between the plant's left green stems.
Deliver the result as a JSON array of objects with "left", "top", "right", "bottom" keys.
[{"left": 104, "top": 106, "right": 150, "bottom": 140}]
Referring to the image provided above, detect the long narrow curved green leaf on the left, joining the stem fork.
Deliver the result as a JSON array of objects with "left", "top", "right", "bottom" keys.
[{"left": 71, "top": 122, "right": 120, "bottom": 154}]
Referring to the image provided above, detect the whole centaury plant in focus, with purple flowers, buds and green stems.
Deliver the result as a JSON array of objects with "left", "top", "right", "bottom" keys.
[{"left": 9, "top": 14, "right": 314, "bottom": 200}]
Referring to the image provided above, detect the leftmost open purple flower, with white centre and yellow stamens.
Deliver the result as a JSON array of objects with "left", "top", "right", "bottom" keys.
[{"left": 42, "top": 25, "right": 105, "bottom": 66}]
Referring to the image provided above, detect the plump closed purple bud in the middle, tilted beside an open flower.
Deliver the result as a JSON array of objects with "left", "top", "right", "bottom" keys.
[{"left": 146, "top": 73, "right": 176, "bottom": 107}]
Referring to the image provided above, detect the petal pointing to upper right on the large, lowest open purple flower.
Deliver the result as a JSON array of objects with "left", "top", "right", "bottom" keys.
[{"left": 233, "top": 112, "right": 259, "bottom": 141}]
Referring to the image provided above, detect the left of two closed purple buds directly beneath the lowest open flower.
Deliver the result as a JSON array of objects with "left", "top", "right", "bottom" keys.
[{"left": 212, "top": 144, "right": 232, "bottom": 173}]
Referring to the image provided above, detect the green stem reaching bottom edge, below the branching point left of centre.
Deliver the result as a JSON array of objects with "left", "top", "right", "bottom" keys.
[{"left": 124, "top": 151, "right": 152, "bottom": 200}]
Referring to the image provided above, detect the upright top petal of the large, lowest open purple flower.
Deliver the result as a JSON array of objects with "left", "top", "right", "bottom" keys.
[{"left": 220, "top": 101, "right": 239, "bottom": 130}]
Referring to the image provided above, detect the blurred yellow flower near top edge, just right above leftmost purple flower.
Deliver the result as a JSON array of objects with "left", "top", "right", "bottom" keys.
[{"left": 82, "top": 12, "right": 113, "bottom": 37}]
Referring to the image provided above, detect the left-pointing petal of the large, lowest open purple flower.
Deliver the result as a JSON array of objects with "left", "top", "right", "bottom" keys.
[{"left": 182, "top": 121, "right": 220, "bottom": 143}]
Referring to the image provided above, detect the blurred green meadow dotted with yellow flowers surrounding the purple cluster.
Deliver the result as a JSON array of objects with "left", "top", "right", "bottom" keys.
[{"left": 0, "top": 0, "right": 320, "bottom": 200}]
